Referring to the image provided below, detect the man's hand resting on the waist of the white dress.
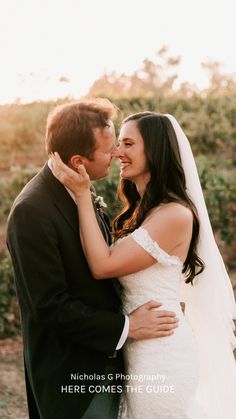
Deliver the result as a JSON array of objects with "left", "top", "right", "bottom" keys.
[{"left": 128, "top": 301, "right": 178, "bottom": 340}]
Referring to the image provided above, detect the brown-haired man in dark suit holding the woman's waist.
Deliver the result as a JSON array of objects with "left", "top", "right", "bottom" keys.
[{"left": 7, "top": 99, "right": 177, "bottom": 419}]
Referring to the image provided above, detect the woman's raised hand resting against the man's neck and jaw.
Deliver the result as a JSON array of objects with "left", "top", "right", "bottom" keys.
[{"left": 50, "top": 152, "right": 90, "bottom": 197}]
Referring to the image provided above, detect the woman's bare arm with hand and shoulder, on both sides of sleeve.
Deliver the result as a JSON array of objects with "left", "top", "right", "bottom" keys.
[{"left": 50, "top": 153, "right": 191, "bottom": 279}]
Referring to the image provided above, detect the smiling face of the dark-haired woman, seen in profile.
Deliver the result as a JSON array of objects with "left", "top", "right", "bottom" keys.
[{"left": 117, "top": 121, "right": 150, "bottom": 183}]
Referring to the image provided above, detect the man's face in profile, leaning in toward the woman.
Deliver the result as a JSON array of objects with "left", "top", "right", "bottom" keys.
[{"left": 83, "top": 121, "right": 116, "bottom": 180}]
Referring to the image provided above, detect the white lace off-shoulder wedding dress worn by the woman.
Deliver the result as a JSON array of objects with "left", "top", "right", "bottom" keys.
[{"left": 119, "top": 227, "right": 205, "bottom": 419}]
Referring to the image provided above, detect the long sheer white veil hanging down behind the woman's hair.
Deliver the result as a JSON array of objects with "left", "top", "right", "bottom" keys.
[{"left": 166, "top": 115, "right": 236, "bottom": 419}]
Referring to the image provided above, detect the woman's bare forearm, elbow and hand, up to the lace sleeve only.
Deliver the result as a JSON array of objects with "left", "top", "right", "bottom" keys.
[{"left": 51, "top": 153, "right": 155, "bottom": 279}]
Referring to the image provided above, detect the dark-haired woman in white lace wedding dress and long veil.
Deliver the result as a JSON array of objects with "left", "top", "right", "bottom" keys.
[{"left": 52, "top": 112, "right": 236, "bottom": 419}]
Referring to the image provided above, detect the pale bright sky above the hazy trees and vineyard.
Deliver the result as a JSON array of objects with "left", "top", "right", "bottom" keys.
[{"left": 0, "top": 0, "right": 236, "bottom": 104}]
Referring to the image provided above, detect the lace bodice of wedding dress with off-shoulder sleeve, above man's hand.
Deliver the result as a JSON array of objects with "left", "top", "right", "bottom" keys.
[{"left": 119, "top": 227, "right": 182, "bottom": 313}]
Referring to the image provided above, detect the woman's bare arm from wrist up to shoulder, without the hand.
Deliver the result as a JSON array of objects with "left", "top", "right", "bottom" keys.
[{"left": 76, "top": 192, "right": 192, "bottom": 279}]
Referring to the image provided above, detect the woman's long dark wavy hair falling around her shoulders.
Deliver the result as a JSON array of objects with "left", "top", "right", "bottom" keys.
[{"left": 113, "top": 112, "right": 204, "bottom": 283}]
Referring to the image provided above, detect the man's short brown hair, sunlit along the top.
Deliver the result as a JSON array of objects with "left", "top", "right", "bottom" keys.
[{"left": 45, "top": 98, "right": 117, "bottom": 163}]
